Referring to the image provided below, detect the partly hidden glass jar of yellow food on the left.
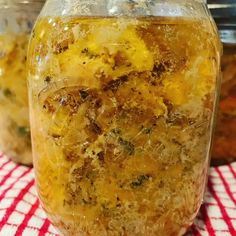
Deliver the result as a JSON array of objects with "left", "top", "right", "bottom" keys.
[{"left": 0, "top": 0, "right": 44, "bottom": 165}]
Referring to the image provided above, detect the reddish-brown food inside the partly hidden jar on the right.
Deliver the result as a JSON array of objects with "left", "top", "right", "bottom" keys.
[{"left": 212, "top": 51, "right": 236, "bottom": 165}]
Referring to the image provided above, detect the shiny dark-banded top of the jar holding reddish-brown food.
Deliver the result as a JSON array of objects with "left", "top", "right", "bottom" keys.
[{"left": 207, "top": 0, "right": 236, "bottom": 44}]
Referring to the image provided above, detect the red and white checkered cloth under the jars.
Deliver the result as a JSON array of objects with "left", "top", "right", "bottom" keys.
[{"left": 0, "top": 154, "right": 236, "bottom": 236}]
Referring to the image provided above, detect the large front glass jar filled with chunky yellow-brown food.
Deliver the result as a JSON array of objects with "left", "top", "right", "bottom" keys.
[{"left": 28, "top": 0, "right": 221, "bottom": 236}]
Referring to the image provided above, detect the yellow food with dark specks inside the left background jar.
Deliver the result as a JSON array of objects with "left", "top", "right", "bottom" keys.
[{"left": 0, "top": 33, "right": 32, "bottom": 165}]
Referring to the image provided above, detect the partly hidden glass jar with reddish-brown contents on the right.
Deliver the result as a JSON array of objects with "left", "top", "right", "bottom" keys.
[{"left": 209, "top": 0, "right": 236, "bottom": 165}]
